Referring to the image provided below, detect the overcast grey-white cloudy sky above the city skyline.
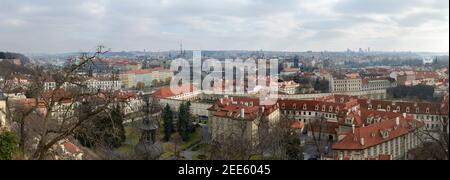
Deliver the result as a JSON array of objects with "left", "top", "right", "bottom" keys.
[{"left": 0, "top": 0, "right": 449, "bottom": 53}]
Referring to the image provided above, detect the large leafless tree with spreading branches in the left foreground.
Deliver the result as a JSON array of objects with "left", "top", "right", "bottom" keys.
[{"left": 5, "top": 46, "right": 130, "bottom": 159}]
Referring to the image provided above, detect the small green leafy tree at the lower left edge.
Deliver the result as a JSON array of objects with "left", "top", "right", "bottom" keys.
[{"left": 0, "top": 131, "right": 18, "bottom": 160}]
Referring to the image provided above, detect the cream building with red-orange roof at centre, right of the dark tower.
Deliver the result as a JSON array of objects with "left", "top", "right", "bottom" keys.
[{"left": 208, "top": 97, "right": 280, "bottom": 146}]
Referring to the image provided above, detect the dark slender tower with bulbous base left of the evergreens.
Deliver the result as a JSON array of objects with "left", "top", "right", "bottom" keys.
[{"left": 134, "top": 96, "right": 163, "bottom": 160}]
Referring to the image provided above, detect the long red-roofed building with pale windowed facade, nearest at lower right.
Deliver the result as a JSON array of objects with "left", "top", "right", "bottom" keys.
[{"left": 332, "top": 111, "right": 424, "bottom": 160}]
